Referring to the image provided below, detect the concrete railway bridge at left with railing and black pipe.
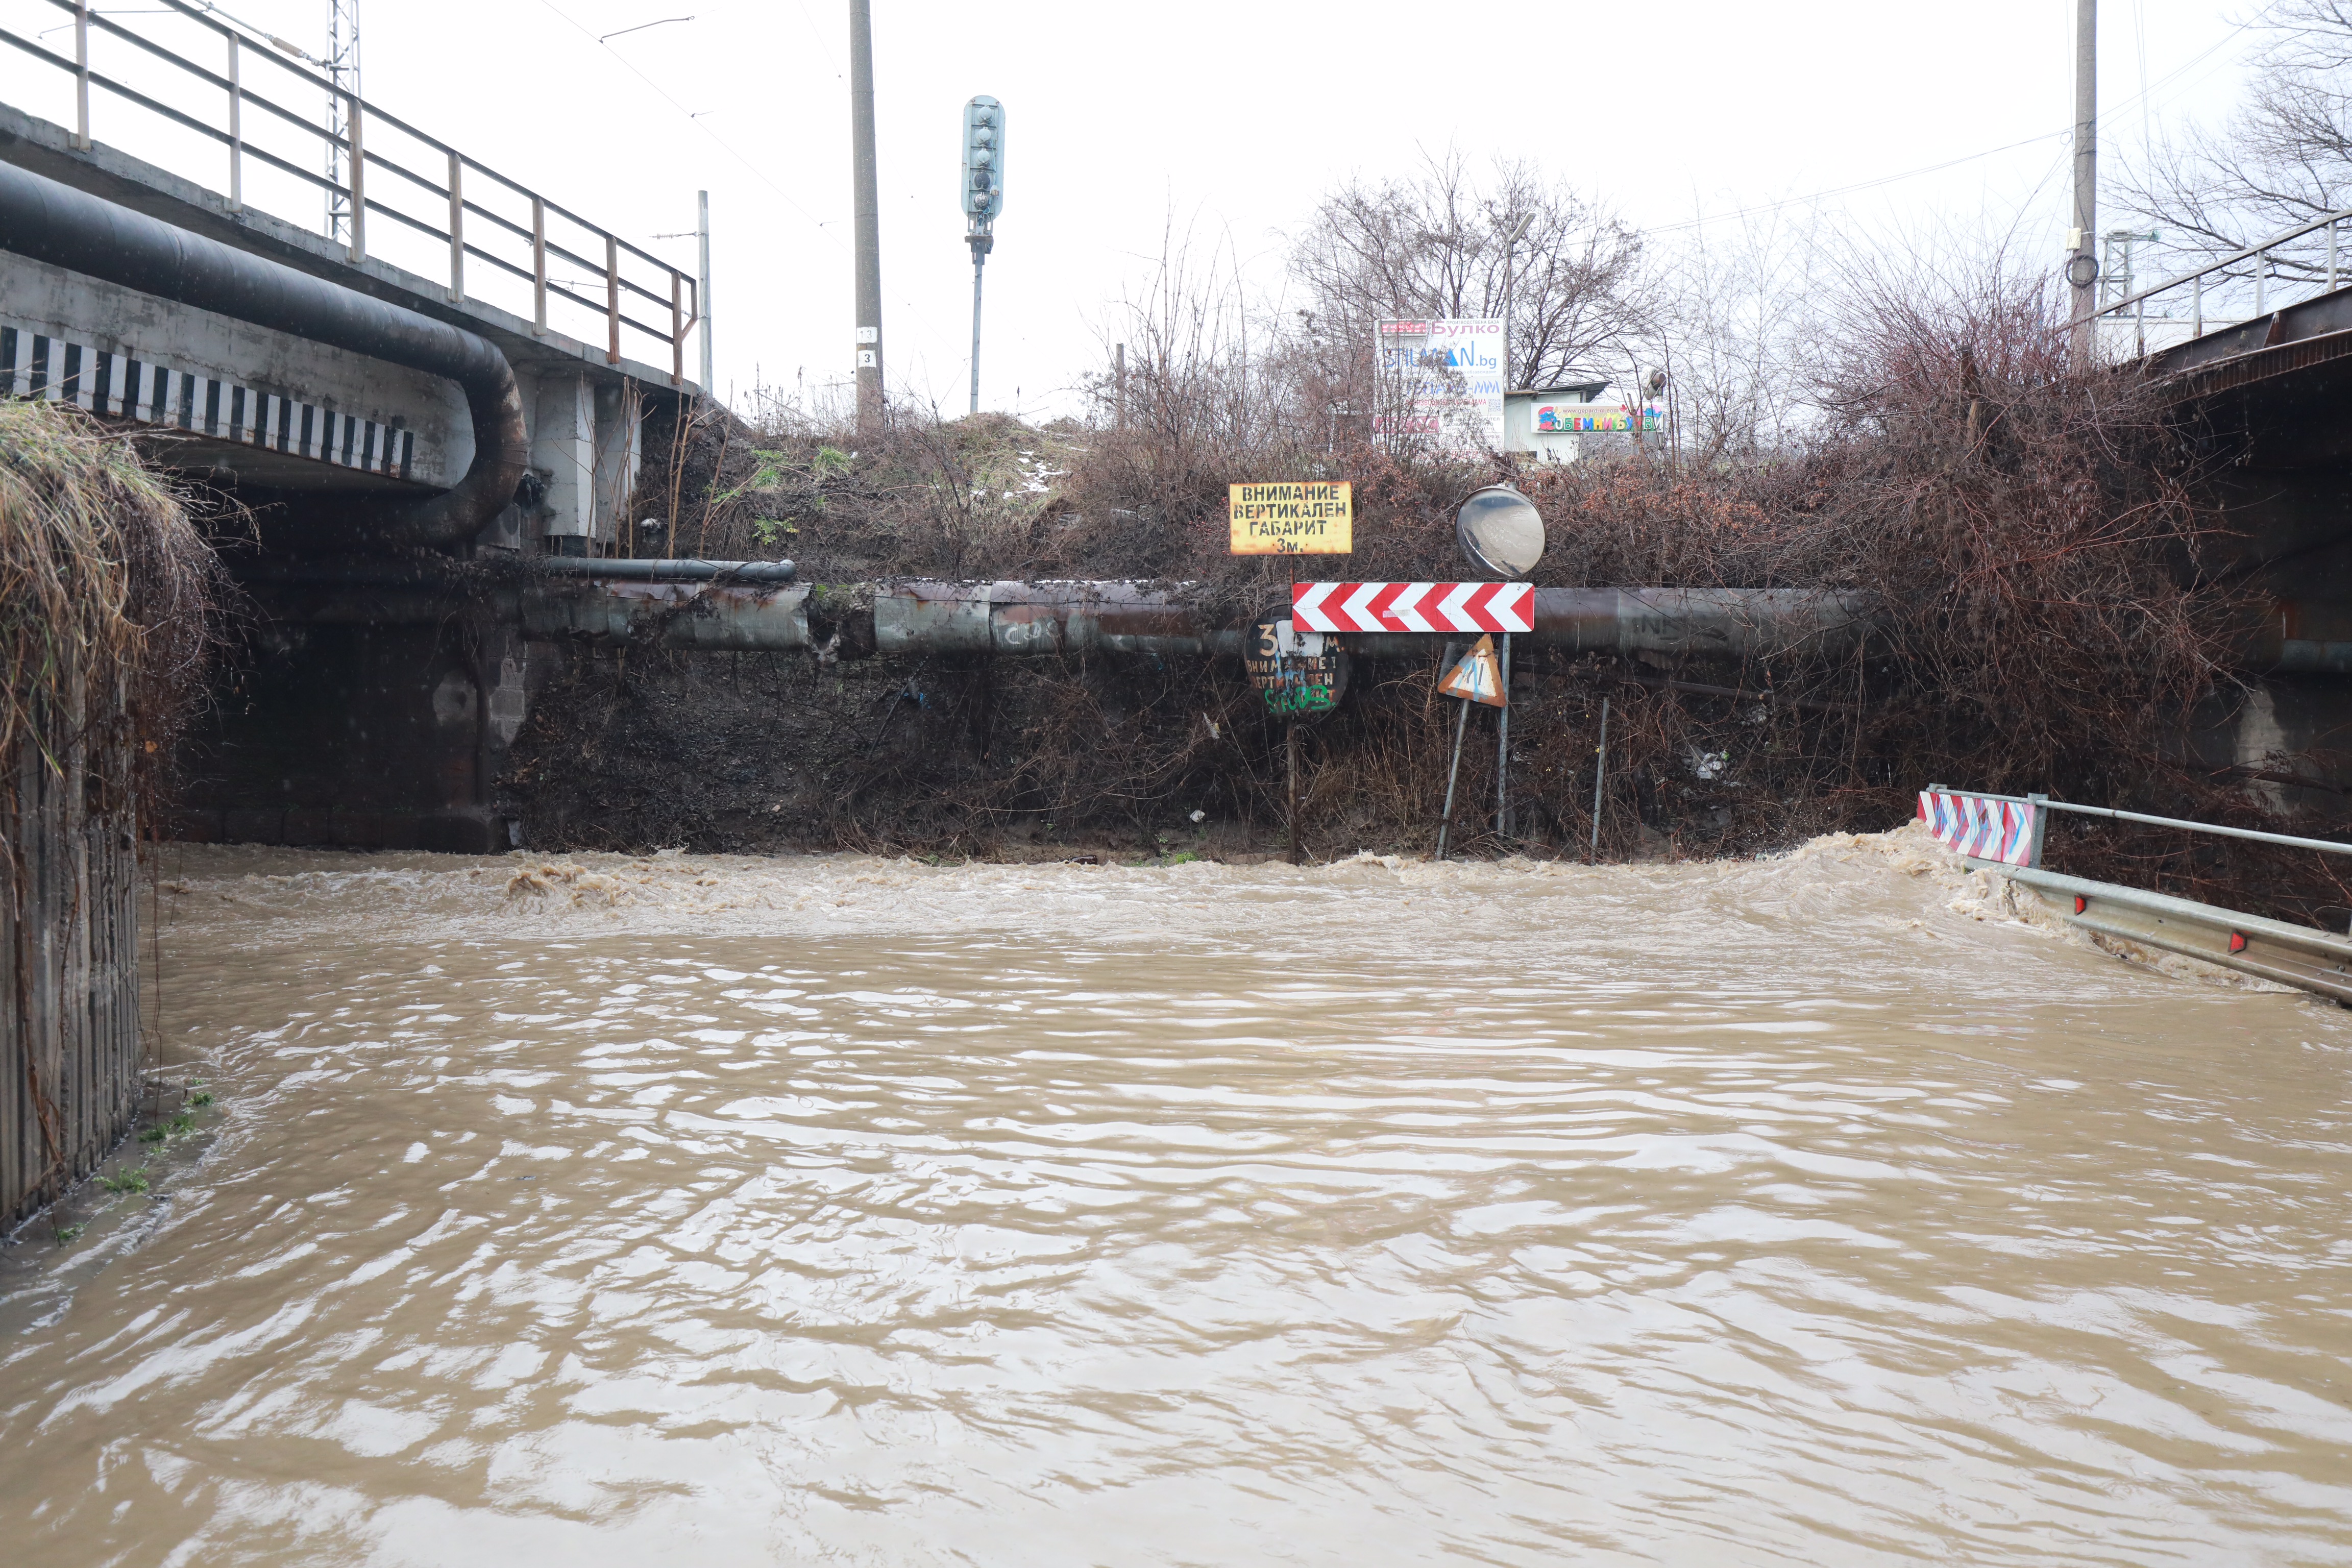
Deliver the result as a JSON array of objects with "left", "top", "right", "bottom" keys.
[{"left": 0, "top": 0, "right": 708, "bottom": 849}]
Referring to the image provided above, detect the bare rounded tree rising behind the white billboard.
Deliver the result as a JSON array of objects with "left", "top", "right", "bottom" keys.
[{"left": 1291, "top": 153, "right": 1656, "bottom": 385}]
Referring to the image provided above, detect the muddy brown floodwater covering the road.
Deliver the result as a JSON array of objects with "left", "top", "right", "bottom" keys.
[{"left": 0, "top": 830, "right": 2352, "bottom": 1568}]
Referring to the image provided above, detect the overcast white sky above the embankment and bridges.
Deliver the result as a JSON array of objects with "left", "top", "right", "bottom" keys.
[{"left": 59, "top": 0, "right": 2256, "bottom": 416}]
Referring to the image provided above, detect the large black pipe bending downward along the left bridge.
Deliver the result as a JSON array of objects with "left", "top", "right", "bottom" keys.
[{"left": 0, "top": 162, "right": 529, "bottom": 548}]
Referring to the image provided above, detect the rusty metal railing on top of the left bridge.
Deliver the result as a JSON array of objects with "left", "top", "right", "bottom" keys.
[{"left": 0, "top": 0, "right": 701, "bottom": 385}]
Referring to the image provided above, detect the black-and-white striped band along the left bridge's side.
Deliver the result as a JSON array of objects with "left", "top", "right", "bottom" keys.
[{"left": 0, "top": 322, "right": 416, "bottom": 480}]
